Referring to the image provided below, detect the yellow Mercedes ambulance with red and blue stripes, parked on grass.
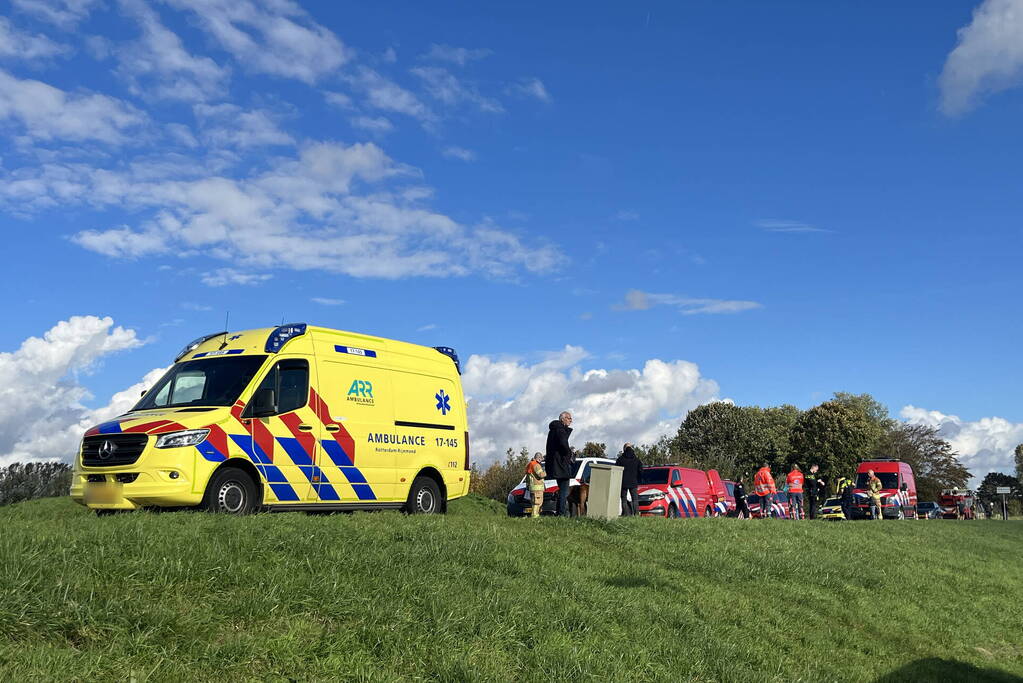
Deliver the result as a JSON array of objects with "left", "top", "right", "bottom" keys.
[{"left": 71, "top": 323, "right": 470, "bottom": 514}]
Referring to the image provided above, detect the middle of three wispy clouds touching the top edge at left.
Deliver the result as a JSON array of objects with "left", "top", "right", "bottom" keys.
[{"left": 119, "top": 0, "right": 229, "bottom": 101}]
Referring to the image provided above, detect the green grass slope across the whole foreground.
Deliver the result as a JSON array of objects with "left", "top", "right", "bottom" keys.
[{"left": 0, "top": 498, "right": 1023, "bottom": 682}]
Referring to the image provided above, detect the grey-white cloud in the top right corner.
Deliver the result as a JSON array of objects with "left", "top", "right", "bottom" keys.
[{"left": 938, "top": 0, "right": 1023, "bottom": 116}]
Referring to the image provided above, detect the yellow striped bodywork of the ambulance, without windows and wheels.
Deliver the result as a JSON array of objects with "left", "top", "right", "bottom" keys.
[{"left": 71, "top": 326, "right": 469, "bottom": 509}]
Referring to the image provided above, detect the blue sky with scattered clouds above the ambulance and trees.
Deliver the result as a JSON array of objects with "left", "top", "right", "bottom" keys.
[{"left": 0, "top": 0, "right": 1023, "bottom": 478}]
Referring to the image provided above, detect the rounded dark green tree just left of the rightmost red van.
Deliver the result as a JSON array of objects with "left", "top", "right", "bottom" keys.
[{"left": 792, "top": 401, "right": 882, "bottom": 482}]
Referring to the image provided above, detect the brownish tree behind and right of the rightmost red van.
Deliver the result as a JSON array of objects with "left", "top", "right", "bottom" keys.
[{"left": 874, "top": 422, "right": 971, "bottom": 500}]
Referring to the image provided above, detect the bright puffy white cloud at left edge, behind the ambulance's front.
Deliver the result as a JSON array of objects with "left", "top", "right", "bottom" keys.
[{"left": 0, "top": 316, "right": 154, "bottom": 465}]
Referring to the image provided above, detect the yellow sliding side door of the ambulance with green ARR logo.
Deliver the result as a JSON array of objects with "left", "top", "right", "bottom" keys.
[{"left": 317, "top": 356, "right": 398, "bottom": 503}]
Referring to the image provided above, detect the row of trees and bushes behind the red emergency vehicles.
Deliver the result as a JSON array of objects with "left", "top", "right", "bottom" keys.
[{"left": 471, "top": 392, "right": 1023, "bottom": 501}]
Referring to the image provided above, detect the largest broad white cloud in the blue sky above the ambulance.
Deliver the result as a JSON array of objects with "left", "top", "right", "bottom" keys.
[{"left": 9, "top": 142, "right": 563, "bottom": 278}]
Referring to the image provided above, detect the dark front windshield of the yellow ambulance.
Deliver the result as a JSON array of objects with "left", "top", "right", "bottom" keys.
[{"left": 132, "top": 356, "right": 266, "bottom": 410}]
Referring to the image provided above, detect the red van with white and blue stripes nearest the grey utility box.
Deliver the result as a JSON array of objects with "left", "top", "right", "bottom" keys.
[{"left": 639, "top": 465, "right": 725, "bottom": 517}]
